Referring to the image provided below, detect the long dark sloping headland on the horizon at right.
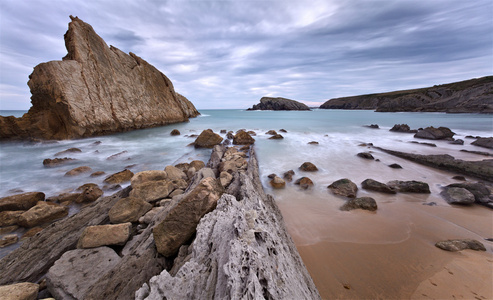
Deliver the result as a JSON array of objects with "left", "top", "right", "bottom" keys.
[{"left": 320, "top": 76, "right": 493, "bottom": 113}]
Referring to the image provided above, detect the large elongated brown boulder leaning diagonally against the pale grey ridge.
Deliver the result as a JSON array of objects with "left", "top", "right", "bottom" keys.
[{"left": 152, "top": 177, "right": 224, "bottom": 257}]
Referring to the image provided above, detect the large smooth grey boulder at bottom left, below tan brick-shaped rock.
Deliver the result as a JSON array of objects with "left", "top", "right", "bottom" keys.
[{"left": 46, "top": 247, "right": 121, "bottom": 299}]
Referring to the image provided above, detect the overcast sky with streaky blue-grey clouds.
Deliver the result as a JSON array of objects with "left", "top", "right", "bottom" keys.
[{"left": 0, "top": 0, "right": 493, "bottom": 110}]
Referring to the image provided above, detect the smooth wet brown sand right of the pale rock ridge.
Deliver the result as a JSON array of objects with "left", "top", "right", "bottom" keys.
[{"left": 266, "top": 146, "right": 493, "bottom": 299}]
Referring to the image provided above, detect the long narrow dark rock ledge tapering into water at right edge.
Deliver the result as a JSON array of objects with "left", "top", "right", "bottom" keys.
[{"left": 377, "top": 147, "right": 493, "bottom": 181}]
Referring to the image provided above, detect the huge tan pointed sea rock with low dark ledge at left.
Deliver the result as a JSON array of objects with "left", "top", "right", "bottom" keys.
[{"left": 0, "top": 16, "right": 199, "bottom": 140}]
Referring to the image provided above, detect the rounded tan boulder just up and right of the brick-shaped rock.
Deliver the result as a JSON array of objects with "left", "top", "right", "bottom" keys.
[{"left": 108, "top": 197, "right": 152, "bottom": 224}]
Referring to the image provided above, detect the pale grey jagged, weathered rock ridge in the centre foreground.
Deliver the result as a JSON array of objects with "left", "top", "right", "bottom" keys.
[{"left": 136, "top": 148, "right": 320, "bottom": 299}]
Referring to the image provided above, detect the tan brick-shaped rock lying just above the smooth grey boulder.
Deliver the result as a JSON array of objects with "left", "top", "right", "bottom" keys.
[{"left": 77, "top": 223, "right": 132, "bottom": 249}]
